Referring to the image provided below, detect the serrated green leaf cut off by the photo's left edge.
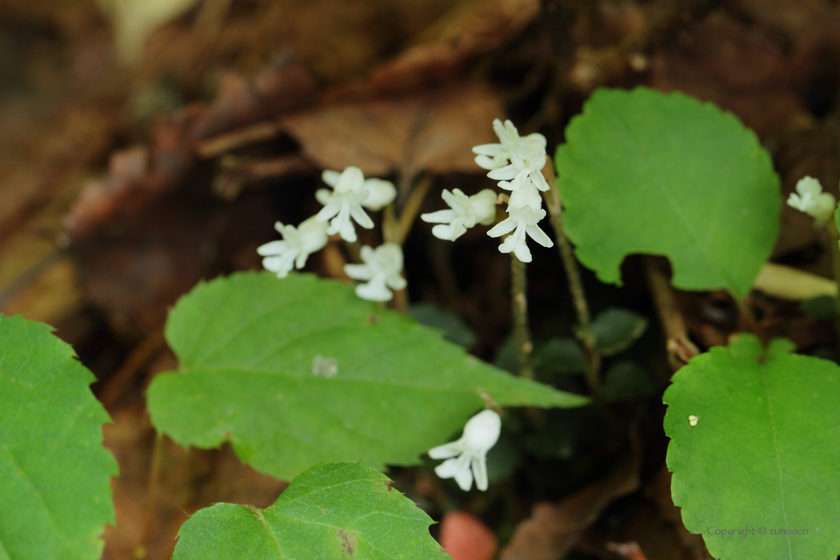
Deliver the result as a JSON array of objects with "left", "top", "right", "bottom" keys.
[{"left": 0, "top": 316, "right": 117, "bottom": 560}]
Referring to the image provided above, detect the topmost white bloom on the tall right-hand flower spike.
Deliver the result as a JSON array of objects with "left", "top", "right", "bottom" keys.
[{"left": 473, "top": 119, "right": 548, "bottom": 192}]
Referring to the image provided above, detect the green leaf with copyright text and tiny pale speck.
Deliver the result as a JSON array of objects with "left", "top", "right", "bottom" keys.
[{"left": 664, "top": 335, "right": 840, "bottom": 560}]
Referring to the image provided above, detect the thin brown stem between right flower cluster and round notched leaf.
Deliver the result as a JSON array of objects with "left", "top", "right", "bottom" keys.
[{"left": 543, "top": 160, "right": 601, "bottom": 393}]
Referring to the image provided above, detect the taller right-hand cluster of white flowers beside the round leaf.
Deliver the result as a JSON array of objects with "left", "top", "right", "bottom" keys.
[{"left": 421, "top": 119, "right": 554, "bottom": 263}]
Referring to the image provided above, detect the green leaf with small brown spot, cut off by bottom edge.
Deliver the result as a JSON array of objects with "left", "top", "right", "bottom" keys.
[{"left": 167, "top": 463, "right": 449, "bottom": 560}]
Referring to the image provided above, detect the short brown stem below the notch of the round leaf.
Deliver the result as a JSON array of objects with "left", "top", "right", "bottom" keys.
[{"left": 644, "top": 256, "right": 700, "bottom": 371}]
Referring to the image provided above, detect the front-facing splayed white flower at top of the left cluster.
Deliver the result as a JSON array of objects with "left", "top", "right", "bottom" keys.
[{"left": 315, "top": 167, "right": 373, "bottom": 242}]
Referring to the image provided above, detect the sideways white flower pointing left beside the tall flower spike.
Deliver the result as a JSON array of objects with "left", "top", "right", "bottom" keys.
[{"left": 420, "top": 189, "right": 496, "bottom": 241}]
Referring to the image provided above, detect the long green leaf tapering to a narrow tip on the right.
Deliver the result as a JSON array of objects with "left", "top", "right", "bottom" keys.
[{"left": 148, "top": 273, "right": 587, "bottom": 480}]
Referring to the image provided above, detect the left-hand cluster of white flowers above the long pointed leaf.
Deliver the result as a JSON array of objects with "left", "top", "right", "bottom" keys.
[{"left": 257, "top": 167, "right": 406, "bottom": 301}]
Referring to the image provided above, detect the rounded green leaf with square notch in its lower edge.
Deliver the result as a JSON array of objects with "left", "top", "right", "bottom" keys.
[{"left": 556, "top": 88, "right": 781, "bottom": 297}]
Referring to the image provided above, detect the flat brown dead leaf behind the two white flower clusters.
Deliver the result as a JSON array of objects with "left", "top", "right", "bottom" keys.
[{"left": 279, "top": 85, "right": 504, "bottom": 182}]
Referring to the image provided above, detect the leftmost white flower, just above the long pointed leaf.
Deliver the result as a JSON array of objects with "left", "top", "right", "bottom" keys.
[{"left": 257, "top": 216, "right": 327, "bottom": 278}]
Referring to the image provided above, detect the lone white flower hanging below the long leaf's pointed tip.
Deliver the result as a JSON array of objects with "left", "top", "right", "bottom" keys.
[{"left": 429, "top": 410, "right": 502, "bottom": 492}]
